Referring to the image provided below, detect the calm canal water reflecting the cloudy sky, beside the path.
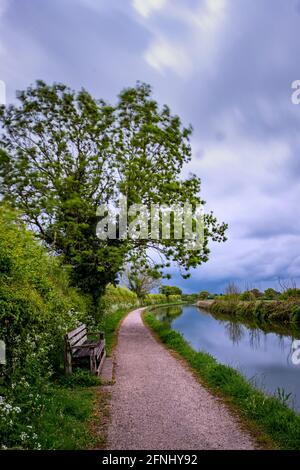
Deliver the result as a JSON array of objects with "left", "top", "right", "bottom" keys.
[{"left": 154, "top": 306, "right": 300, "bottom": 412}]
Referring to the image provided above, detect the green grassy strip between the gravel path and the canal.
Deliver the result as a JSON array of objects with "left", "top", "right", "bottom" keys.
[{"left": 144, "top": 311, "right": 300, "bottom": 450}]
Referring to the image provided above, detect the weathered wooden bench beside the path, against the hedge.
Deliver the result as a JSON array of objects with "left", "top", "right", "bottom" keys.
[{"left": 65, "top": 324, "right": 106, "bottom": 375}]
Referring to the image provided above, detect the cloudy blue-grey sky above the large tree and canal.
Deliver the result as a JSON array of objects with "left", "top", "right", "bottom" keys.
[{"left": 0, "top": 0, "right": 300, "bottom": 292}]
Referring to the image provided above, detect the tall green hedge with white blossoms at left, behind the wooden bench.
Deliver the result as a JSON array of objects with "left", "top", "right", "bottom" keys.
[{"left": 0, "top": 205, "right": 92, "bottom": 448}]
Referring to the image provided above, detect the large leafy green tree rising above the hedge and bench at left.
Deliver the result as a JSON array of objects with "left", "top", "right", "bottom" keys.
[{"left": 0, "top": 81, "right": 226, "bottom": 300}]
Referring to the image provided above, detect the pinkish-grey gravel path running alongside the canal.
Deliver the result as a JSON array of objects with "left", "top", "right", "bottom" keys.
[{"left": 107, "top": 310, "right": 255, "bottom": 450}]
